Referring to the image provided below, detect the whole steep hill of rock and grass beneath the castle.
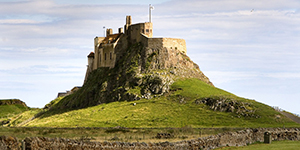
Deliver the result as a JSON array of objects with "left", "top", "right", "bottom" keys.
[{"left": 24, "top": 43, "right": 299, "bottom": 128}]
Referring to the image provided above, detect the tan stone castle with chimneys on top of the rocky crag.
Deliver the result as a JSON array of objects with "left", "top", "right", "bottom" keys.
[{"left": 85, "top": 16, "right": 186, "bottom": 81}]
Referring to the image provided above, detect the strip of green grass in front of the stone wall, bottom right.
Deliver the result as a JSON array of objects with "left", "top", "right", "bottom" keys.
[{"left": 217, "top": 141, "right": 300, "bottom": 150}]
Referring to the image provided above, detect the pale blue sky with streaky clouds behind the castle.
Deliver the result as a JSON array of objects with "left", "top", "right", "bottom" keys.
[{"left": 0, "top": 0, "right": 300, "bottom": 114}]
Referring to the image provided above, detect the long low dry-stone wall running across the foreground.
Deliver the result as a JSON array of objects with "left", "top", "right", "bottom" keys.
[{"left": 0, "top": 128, "right": 300, "bottom": 150}]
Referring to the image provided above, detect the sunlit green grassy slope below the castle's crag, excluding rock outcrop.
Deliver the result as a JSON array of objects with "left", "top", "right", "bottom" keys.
[{"left": 27, "top": 79, "right": 299, "bottom": 127}]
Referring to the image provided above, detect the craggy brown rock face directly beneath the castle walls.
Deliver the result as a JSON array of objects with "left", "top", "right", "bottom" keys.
[{"left": 52, "top": 43, "right": 213, "bottom": 109}]
